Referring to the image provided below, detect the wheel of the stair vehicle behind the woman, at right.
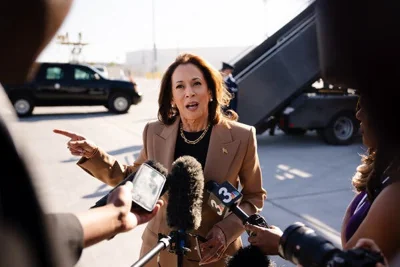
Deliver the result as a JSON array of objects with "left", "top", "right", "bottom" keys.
[{"left": 318, "top": 112, "right": 359, "bottom": 145}]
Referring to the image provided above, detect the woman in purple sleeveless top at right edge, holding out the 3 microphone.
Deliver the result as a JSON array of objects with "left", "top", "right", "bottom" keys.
[{"left": 247, "top": 93, "right": 400, "bottom": 261}]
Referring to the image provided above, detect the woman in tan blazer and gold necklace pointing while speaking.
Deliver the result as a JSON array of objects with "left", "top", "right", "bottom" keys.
[{"left": 55, "top": 54, "right": 266, "bottom": 267}]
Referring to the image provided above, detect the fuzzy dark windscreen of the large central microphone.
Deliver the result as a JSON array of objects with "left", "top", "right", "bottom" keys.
[{"left": 167, "top": 156, "right": 204, "bottom": 231}]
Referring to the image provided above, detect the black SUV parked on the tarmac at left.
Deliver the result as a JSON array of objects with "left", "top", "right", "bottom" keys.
[{"left": 3, "top": 63, "right": 142, "bottom": 117}]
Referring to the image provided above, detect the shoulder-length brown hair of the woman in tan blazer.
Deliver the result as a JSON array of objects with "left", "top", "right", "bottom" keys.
[{"left": 158, "top": 53, "right": 238, "bottom": 125}]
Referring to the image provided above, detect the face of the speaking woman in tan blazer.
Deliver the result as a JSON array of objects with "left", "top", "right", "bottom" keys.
[{"left": 171, "top": 63, "right": 211, "bottom": 124}]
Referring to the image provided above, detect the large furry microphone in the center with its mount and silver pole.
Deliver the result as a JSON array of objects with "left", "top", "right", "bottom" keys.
[{"left": 131, "top": 156, "right": 204, "bottom": 267}]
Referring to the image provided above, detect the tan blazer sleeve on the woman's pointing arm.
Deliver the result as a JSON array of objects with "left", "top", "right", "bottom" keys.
[{"left": 77, "top": 123, "right": 149, "bottom": 186}]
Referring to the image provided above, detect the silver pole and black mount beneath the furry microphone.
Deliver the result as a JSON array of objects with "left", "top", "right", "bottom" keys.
[{"left": 131, "top": 230, "right": 190, "bottom": 267}]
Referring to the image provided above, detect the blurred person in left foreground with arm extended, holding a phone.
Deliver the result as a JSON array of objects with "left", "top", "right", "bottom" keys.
[{"left": 0, "top": 0, "right": 163, "bottom": 267}]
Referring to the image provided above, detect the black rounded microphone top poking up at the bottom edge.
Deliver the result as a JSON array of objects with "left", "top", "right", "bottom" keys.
[{"left": 226, "top": 245, "right": 274, "bottom": 267}]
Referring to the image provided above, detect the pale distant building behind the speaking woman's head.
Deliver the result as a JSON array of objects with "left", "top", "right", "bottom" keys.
[{"left": 125, "top": 46, "right": 249, "bottom": 76}]
